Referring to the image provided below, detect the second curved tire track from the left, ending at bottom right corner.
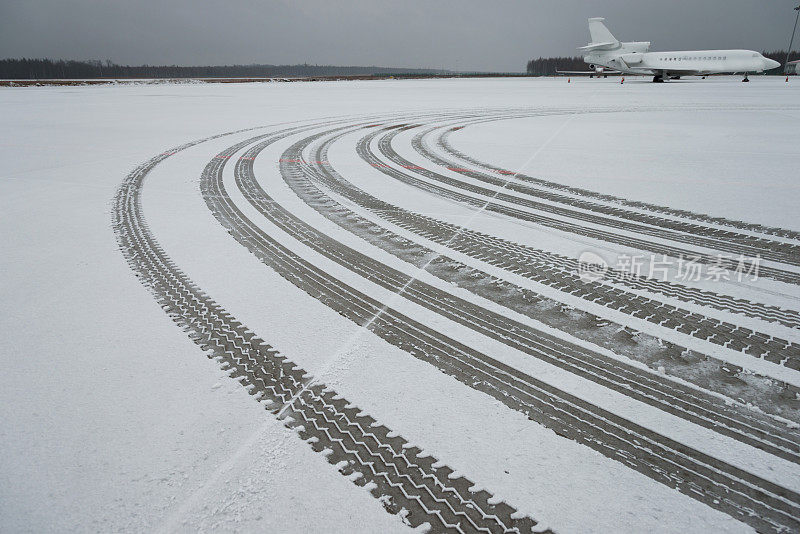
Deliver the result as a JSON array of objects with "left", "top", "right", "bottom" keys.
[{"left": 202, "top": 121, "right": 800, "bottom": 532}]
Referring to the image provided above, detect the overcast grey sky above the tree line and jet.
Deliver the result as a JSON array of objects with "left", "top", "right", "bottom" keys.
[{"left": 0, "top": 0, "right": 800, "bottom": 71}]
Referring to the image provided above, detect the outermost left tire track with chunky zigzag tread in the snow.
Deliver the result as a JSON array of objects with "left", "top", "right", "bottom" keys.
[{"left": 113, "top": 130, "right": 536, "bottom": 533}]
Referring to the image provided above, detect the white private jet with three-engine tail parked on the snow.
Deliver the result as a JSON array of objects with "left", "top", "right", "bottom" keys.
[{"left": 579, "top": 18, "right": 780, "bottom": 82}]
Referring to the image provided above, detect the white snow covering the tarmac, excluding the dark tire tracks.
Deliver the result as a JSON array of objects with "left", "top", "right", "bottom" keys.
[{"left": 0, "top": 77, "right": 800, "bottom": 532}]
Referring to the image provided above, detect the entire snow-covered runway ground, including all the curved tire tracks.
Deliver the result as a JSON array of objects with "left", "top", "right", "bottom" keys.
[{"left": 0, "top": 78, "right": 800, "bottom": 532}]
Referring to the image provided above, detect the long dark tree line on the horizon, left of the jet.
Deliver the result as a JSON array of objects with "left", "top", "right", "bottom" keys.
[{"left": 0, "top": 58, "right": 447, "bottom": 80}]
